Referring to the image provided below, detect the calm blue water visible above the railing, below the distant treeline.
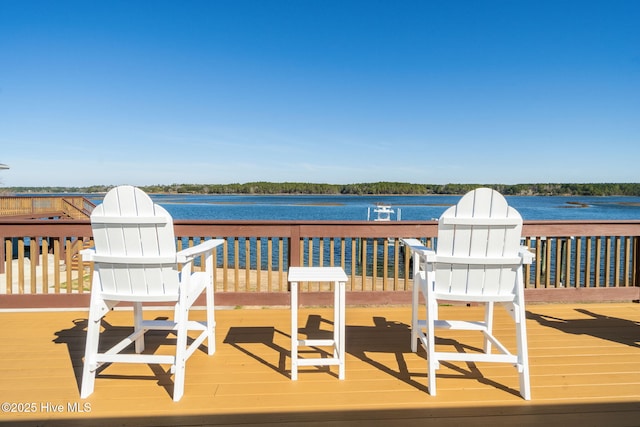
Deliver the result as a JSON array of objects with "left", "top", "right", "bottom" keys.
[{"left": 91, "top": 195, "right": 640, "bottom": 220}]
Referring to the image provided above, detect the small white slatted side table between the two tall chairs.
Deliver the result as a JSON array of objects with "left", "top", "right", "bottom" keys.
[{"left": 288, "top": 267, "right": 349, "bottom": 380}]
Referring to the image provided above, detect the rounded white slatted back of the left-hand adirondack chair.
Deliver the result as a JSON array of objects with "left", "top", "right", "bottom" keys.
[{"left": 91, "top": 186, "right": 179, "bottom": 301}]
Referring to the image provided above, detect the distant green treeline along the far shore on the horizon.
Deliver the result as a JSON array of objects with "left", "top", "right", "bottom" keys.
[{"left": 0, "top": 182, "right": 640, "bottom": 196}]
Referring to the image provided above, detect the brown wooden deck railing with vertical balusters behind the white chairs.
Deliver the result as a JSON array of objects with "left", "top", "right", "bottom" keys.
[{"left": 0, "top": 218, "right": 640, "bottom": 302}]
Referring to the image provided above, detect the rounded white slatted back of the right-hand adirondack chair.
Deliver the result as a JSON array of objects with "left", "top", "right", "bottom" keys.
[{"left": 434, "top": 188, "right": 522, "bottom": 301}]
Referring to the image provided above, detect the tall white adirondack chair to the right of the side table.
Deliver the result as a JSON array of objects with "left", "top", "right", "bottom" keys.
[{"left": 404, "top": 188, "right": 533, "bottom": 400}]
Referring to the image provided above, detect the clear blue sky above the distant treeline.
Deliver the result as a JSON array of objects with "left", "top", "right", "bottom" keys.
[{"left": 0, "top": 0, "right": 640, "bottom": 186}]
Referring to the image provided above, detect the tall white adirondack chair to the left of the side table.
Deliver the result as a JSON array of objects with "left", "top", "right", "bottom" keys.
[{"left": 80, "top": 186, "right": 222, "bottom": 402}]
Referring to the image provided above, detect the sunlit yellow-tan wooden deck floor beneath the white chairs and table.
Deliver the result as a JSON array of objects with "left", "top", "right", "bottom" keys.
[{"left": 0, "top": 303, "right": 640, "bottom": 427}]
